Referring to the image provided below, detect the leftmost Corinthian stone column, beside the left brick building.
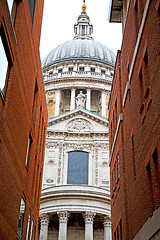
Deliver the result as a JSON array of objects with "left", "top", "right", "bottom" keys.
[{"left": 40, "top": 213, "right": 49, "bottom": 240}]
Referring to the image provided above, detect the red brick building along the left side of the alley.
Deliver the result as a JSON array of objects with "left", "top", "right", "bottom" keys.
[{"left": 0, "top": 0, "right": 47, "bottom": 240}]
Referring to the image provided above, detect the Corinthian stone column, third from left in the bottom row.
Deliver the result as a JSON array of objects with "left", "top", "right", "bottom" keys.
[{"left": 83, "top": 212, "right": 96, "bottom": 240}]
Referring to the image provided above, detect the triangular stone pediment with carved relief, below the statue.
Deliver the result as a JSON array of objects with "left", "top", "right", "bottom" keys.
[{"left": 48, "top": 109, "right": 108, "bottom": 133}]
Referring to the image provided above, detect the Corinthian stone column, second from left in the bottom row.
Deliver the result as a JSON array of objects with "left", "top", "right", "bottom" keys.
[{"left": 57, "top": 211, "right": 70, "bottom": 240}]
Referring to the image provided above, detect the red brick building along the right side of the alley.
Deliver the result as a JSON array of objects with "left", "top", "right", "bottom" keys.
[{"left": 109, "top": 0, "right": 160, "bottom": 240}]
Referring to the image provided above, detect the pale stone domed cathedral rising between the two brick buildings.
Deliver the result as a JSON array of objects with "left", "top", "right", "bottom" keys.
[{"left": 40, "top": 1, "right": 114, "bottom": 240}]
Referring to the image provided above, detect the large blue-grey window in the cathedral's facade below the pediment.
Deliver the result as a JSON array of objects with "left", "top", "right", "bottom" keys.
[{"left": 67, "top": 151, "right": 89, "bottom": 184}]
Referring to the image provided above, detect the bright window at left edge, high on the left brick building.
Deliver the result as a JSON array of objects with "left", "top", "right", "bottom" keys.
[{"left": 0, "top": 28, "right": 12, "bottom": 100}]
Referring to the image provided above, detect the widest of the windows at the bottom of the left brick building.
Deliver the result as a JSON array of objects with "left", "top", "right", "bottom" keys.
[{"left": 17, "top": 198, "right": 25, "bottom": 240}]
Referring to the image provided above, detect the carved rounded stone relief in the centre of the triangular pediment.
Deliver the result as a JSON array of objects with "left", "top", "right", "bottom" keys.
[{"left": 67, "top": 118, "right": 93, "bottom": 132}]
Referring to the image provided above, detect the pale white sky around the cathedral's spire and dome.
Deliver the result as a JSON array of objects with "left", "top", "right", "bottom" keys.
[{"left": 40, "top": 0, "right": 122, "bottom": 61}]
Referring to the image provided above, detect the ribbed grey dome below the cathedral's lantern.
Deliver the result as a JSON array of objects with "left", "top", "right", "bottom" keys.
[{"left": 42, "top": 38, "right": 116, "bottom": 69}]
